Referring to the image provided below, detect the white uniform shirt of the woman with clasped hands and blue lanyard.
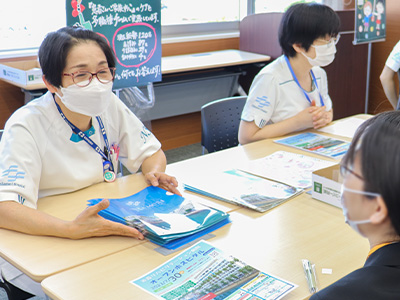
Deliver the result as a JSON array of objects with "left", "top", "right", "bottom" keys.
[{"left": 241, "top": 56, "right": 332, "bottom": 128}]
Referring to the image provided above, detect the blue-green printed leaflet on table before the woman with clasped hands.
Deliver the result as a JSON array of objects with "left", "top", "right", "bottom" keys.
[{"left": 274, "top": 132, "right": 350, "bottom": 159}]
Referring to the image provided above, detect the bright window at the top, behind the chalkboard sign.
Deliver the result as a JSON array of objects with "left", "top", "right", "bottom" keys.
[{"left": 0, "top": 0, "right": 330, "bottom": 58}]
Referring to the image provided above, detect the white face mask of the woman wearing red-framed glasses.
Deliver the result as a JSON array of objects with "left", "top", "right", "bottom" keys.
[{"left": 56, "top": 78, "right": 113, "bottom": 117}]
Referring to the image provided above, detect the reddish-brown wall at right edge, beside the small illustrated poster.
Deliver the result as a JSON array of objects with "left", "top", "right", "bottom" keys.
[{"left": 368, "top": 0, "right": 400, "bottom": 114}]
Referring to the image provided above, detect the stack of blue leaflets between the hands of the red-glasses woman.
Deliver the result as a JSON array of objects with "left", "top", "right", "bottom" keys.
[{"left": 88, "top": 186, "right": 229, "bottom": 249}]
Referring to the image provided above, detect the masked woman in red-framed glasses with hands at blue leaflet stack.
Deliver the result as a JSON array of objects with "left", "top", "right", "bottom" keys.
[{"left": 0, "top": 27, "right": 179, "bottom": 294}]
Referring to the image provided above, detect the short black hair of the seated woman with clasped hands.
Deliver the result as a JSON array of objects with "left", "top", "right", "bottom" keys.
[{"left": 279, "top": 3, "right": 340, "bottom": 57}]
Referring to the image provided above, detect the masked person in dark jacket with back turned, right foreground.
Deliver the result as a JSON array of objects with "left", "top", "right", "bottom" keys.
[{"left": 310, "top": 111, "right": 400, "bottom": 300}]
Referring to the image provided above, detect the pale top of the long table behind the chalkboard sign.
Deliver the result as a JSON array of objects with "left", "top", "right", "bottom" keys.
[{"left": 0, "top": 49, "right": 271, "bottom": 91}]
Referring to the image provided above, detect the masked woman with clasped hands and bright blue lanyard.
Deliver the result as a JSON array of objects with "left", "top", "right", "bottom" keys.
[{"left": 239, "top": 3, "right": 340, "bottom": 144}]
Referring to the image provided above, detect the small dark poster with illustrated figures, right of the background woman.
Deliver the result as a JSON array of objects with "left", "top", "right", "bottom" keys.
[{"left": 354, "top": 0, "right": 386, "bottom": 44}]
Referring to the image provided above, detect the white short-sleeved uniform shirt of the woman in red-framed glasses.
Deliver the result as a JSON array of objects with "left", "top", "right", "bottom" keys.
[{"left": 0, "top": 92, "right": 161, "bottom": 208}]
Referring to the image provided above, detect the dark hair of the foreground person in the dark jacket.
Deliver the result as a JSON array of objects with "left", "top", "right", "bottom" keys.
[{"left": 342, "top": 111, "right": 400, "bottom": 235}]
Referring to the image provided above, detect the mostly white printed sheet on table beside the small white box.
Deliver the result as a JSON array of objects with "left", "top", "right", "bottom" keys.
[{"left": 239, "top": 151, "right": 336, "bottom": 189}]
